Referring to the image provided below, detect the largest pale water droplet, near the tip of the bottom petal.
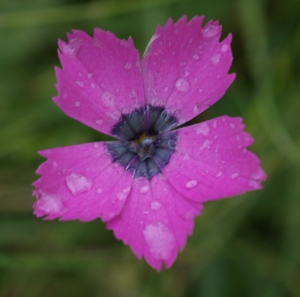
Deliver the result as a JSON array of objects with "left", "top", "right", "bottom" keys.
[{"left": 143, "top": 222, "right": 176, "bottom": 260}]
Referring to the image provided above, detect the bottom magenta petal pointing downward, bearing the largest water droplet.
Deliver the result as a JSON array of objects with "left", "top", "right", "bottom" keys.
[{"left": 107, "top": 175, "right": 202, "bottom": 270}]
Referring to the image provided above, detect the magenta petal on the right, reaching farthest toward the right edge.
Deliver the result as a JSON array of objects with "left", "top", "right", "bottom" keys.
[{"left": 163, "top": 116, "right": 266, "bottom": 203}]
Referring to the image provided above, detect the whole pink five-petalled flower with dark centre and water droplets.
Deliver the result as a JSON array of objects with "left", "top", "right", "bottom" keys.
[{"left": 34, "top": 17, "right": 265, "bottom": 270}]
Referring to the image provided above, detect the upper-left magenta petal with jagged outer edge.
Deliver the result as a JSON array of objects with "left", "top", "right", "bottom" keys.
[{"left": 54, "top": 29, "right": 145, "bottom": 134}]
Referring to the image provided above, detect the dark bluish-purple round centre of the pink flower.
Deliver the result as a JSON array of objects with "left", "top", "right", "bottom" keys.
[{"left": 107, "top": 105, "right": 177, "bottom": 180}]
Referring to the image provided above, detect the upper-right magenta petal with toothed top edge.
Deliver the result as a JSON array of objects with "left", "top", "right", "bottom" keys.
[{"left": 142, "top": 17, "right": 235, "bottom": 124}]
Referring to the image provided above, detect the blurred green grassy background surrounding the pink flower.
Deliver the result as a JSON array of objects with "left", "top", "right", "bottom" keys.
[{"left": 0, "top": 0, "right": 300, "bottom": 297}]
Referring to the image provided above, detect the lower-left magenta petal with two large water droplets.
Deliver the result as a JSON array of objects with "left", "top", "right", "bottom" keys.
[{"left": 33, "top": 143, "right": 132, "bottom": 221}]
